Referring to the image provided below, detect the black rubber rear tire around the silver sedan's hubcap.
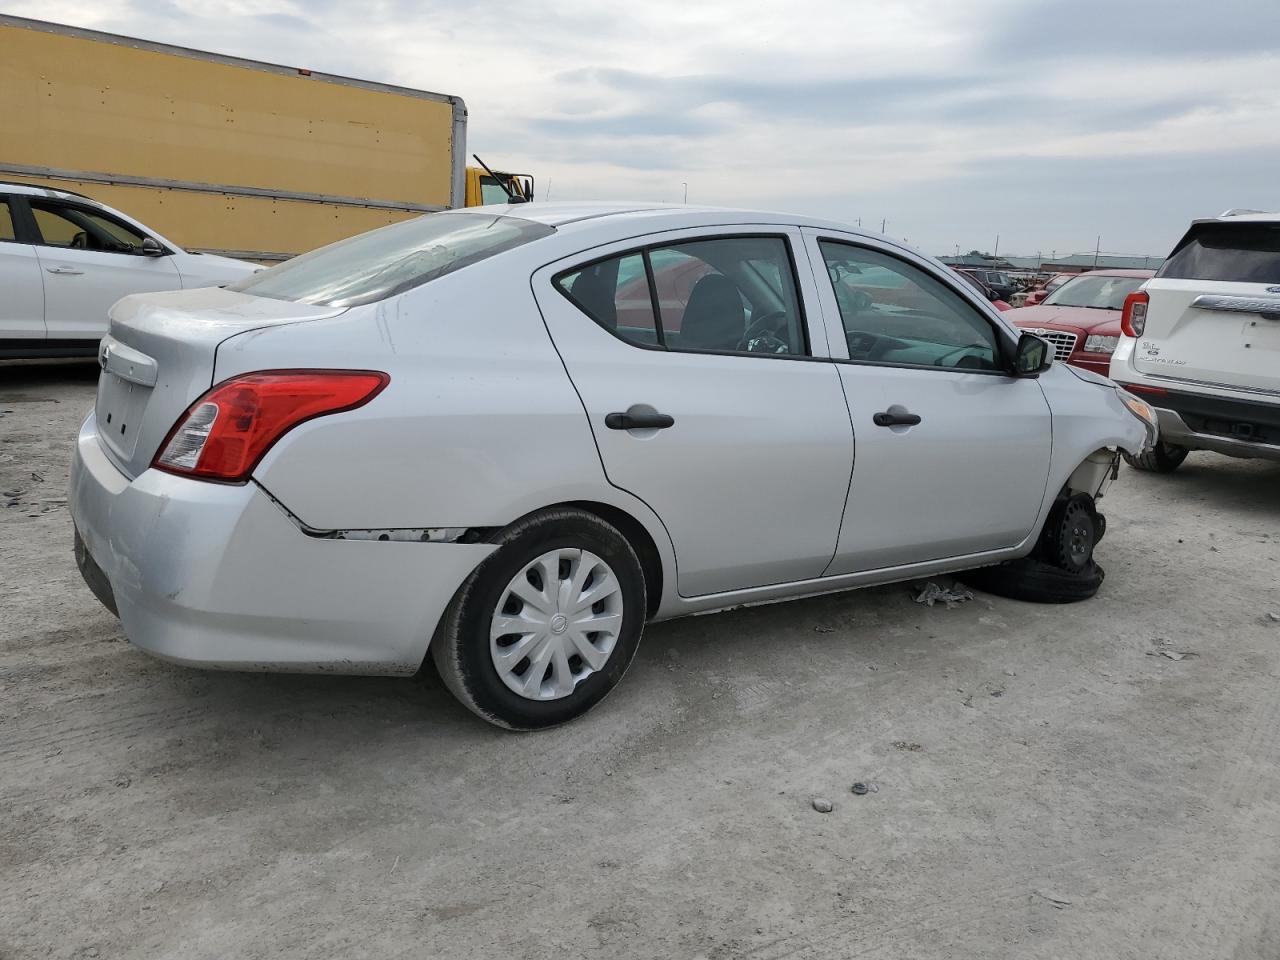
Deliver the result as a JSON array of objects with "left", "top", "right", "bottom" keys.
[{"left": 430, "top": 507, "right": 646, "bottom": 731}]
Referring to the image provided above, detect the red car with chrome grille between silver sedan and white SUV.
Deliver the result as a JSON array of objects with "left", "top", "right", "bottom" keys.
[{"left": 1006, "top": 270, "right": 1156, "bottom": 376}]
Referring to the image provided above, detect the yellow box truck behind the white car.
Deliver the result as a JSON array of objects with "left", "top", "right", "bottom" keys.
[{"left": 0, "top": 15, "right": 532, "bottom": 262}]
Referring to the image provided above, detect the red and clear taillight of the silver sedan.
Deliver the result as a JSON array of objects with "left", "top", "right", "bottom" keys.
[{"left": 151, "top": 370, "right": 390, "bottom": 483}]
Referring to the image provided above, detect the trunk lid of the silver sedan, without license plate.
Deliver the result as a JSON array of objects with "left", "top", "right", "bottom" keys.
[{"left": 95, "top": 288, "right": 344, "bottom": 477}]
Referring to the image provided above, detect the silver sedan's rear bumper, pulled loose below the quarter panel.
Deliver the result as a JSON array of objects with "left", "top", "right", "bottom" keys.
[{"left": 69, "top": 415, "right": 494, "bottom": 675}]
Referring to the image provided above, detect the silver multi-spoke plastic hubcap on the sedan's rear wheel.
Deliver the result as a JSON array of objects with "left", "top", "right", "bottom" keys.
[{"left": 489, "top": 548, "right": 622, "bottom": 700}]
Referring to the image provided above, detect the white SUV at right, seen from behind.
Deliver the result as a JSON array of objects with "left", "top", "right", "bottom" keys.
[{"left": 1111, "top": 210, "right": 1280, "bottom": 474}]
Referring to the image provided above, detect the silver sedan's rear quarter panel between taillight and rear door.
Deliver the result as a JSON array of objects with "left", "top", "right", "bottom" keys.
[{"left": 225, "top": 257, "right": 669, "bottom": 549}]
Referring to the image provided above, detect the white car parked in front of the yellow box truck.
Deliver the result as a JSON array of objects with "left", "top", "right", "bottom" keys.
[{"left": 0, "top": 182, "right": 261, "bottom": 358}]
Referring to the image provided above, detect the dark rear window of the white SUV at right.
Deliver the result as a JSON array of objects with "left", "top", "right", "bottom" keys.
[{"left": 1156, "top": 223, "right": 1280, "bottom": 283}]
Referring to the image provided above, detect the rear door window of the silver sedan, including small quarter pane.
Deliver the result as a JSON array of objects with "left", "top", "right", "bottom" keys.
[{"left": 556, "top": 237, "right": 808, "bottom": 356}]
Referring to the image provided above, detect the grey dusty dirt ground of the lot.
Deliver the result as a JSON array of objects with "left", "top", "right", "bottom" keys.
[{"left": 0, "top": 365, "right": 1280, "bottom": 960}]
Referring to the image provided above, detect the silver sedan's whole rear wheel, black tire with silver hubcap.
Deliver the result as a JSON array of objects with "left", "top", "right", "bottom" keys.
[{"left": 431, "top": 508, "right": 645, "bottom": 730}]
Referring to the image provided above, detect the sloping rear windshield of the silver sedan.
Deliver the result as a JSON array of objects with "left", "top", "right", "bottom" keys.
[{"left": 229, "top": 212, "right": 556, "bottom": 307}]
